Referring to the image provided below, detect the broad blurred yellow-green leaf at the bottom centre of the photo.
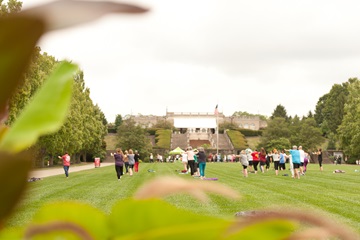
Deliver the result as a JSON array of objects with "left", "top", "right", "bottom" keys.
[{"left": 110, "top": 199, "right": 231, "bottom": 240}]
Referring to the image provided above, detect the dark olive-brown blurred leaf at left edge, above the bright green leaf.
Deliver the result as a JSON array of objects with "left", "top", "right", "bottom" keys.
[{"left": 0, "top": 16, "right": 44, "bottom": 119}]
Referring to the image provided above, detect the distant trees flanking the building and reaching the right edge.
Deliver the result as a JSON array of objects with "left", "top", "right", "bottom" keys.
[{"left": 113, "top": 78, "right": 360, "bottom": 162}]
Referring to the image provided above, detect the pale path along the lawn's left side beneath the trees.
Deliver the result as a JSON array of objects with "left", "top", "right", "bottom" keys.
[{"left": 29, "top": 162, "right": 114, "bottom": 178}]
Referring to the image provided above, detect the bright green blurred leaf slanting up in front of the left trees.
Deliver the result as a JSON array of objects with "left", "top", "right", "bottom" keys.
[{"left": 0, "top": 62, "right": 77, "bottom": 152}]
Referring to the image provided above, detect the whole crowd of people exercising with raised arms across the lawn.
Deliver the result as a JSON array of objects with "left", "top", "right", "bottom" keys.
[{"left": 58, "top": 146, "right": 323, "bottom": 180}]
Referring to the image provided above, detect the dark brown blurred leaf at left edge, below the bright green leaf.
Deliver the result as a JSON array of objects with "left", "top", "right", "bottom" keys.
[{"left": 0, "top": 152, "right": 32, "bottom": 229}]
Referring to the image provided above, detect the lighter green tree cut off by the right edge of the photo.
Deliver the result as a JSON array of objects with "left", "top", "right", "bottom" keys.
[{"left": 338, "top": 80, "right": 360, "bottom": 158}]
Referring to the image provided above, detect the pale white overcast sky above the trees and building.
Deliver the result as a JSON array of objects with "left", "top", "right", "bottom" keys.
[{"left": 23, "top": 0, "right": 360, "bottom": 122}]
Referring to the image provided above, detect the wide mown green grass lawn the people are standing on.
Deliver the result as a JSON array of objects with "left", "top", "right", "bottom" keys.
[{"left": 4, "top": 160, "right": 360, "bottom": 233}]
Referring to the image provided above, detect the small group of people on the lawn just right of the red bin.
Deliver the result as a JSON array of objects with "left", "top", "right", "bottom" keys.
[{"left": 112, "top": 148, "right": 140, "bottom": 180}]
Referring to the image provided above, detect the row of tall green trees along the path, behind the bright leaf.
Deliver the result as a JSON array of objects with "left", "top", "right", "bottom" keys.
[{"left": 6, "top": 47, "right": 107, "bottom": 166}]
